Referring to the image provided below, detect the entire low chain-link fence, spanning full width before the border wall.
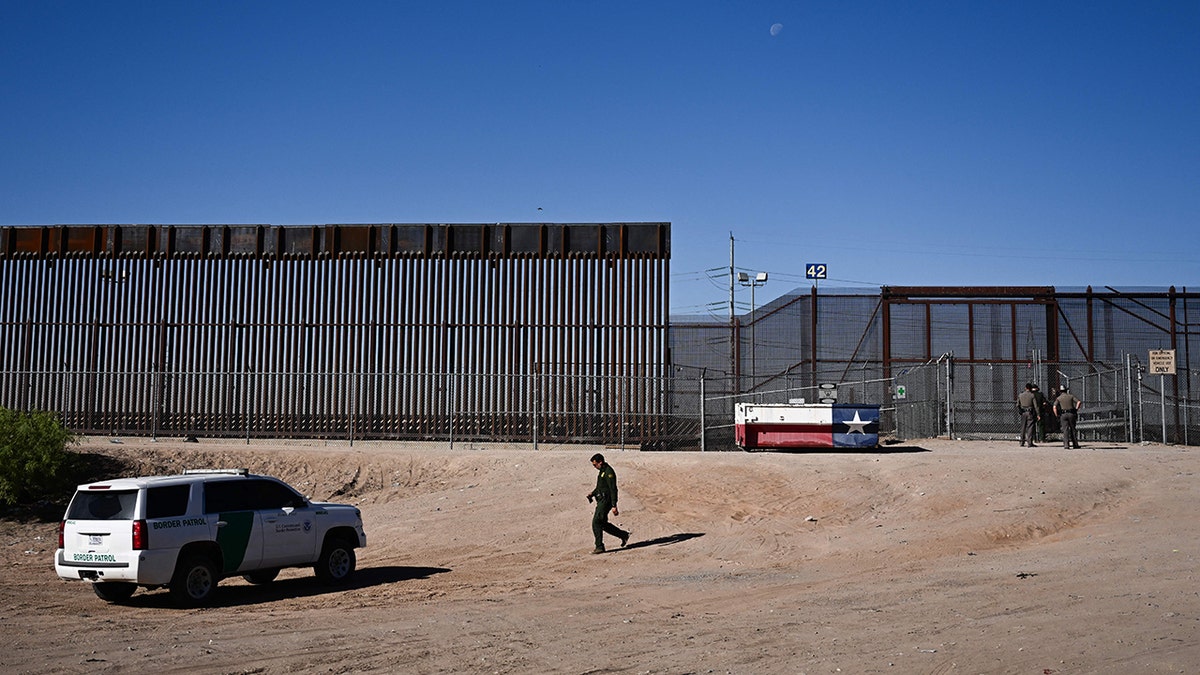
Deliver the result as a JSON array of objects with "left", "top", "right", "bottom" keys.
[{"left": 0, "top": 354, "right": 1200, "bottom": 450}]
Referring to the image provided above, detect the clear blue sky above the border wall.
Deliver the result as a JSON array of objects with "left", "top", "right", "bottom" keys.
[{"left": 0, "top": 0, "right": 1200, "bottom": 316}]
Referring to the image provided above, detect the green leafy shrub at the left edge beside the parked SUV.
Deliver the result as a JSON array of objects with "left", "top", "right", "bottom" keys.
[{"left": 0, "top": 408, "right": 76, "bottom": 506}]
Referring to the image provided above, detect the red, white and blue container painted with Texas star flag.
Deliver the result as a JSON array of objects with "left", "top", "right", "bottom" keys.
[{"left": 734, "top": 404, "right": 880, "bottom": 450}]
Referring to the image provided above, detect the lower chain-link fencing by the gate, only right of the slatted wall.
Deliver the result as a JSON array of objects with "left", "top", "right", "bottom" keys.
[{"left": 676, "top": 353, "right": 1200, "bottom": 450}]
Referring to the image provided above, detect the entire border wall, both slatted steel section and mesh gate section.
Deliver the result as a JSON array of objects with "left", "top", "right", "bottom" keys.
[{"left": 0, "top": 223, "right": 1200, "bottom": 450}]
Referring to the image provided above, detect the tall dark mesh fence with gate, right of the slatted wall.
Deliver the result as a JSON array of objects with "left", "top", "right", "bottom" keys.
[{"left": 671, "top": 287, "right": 1200, "bottom": 446}]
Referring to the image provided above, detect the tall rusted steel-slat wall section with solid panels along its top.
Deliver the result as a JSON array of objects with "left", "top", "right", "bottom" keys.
[{"left": 0, "top": 223, "right": 670, "bottom": 442}]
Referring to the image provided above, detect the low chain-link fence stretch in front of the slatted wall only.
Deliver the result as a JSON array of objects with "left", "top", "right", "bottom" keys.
[{"left": 0, "top": 371, "right": 700, "bottom": 449}]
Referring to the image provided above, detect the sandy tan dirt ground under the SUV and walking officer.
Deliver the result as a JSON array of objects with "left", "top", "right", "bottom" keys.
[{"left": 0, "top": 438, "right": 1200, "bottom": 675}]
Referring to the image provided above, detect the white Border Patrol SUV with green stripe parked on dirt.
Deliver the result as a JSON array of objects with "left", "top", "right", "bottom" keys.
[{"left": 54, "top": 468, "right": 367, "bottom": 607}]
